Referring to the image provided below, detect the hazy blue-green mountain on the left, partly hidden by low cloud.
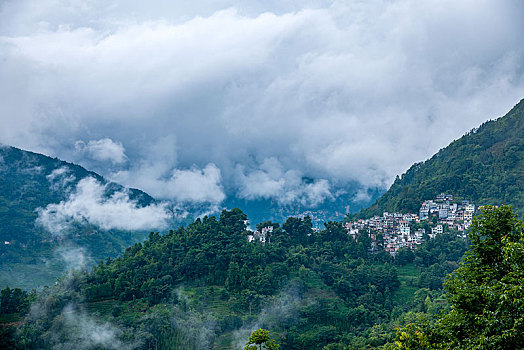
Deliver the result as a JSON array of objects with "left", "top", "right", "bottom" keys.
[{"left": 0, "top": 146, "right": 160, "bottom": 287}]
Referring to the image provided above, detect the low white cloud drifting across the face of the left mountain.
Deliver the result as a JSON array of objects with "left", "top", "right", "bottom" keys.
[{"left": 36, "top": 177, "right": 170, "bottom": 235}]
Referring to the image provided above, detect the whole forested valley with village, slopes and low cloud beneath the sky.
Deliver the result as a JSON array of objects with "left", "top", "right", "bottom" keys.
[{"left": 0, "top": 101, "right": 524, "bottom": 350}]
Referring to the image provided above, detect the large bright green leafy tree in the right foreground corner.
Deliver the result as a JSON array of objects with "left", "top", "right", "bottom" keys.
[{"left": 395, "top": 206, "right": 524, "bottom": 350}]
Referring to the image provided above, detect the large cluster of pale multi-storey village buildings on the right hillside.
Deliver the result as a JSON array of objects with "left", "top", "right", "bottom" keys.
[{"left": 345, "top": 193, "right": 475, "bottom": 255}]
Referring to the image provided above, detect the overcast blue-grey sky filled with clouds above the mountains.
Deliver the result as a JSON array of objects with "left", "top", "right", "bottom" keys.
[{"left": 0, "top": 0, "right": 524, "bottom": 205}]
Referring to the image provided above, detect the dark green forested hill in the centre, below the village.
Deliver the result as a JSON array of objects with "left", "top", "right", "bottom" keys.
[{"left": 2, "top": 209, "right": 474, "bottom": 349}]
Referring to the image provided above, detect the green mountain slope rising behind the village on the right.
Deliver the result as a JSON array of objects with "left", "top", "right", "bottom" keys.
[{"left": 355, "top": 99, "right": 524, "bottom": 217}]
